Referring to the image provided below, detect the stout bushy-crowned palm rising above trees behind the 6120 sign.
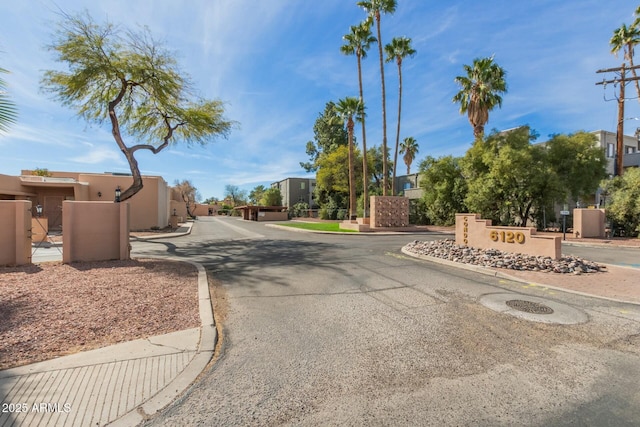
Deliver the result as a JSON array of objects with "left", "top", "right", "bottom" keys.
[{"left": 453, "top": 56, "right": 507, "bottom": 139}]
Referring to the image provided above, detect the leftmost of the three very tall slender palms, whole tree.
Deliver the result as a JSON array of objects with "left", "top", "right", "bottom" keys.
[{"left": 340, "top": 18, "right": 376, "bottom": 218}]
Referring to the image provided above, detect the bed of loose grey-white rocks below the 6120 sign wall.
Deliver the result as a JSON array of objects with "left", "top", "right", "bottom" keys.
[{"left": 405, "top": 239, "right": 606, "bottom": 274}]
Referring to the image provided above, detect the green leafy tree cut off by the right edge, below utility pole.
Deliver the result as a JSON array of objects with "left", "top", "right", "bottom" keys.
[{"left": 602, "top": 168, "right": 640, "bottom": 236}]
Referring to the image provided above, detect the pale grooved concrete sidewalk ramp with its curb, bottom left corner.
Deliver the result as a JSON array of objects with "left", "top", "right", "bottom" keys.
[{"left": 0, "top": 263, "right": 217, "bottom": 427}]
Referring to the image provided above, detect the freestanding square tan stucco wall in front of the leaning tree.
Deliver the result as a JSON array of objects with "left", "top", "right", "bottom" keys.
[{"left": 62, "top": 201, "right": 130, "bottom": 263}]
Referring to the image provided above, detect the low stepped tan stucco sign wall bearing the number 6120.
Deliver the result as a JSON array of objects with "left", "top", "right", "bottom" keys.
[{"left": 456, "top": 214, "right": 562, "bottom": 259}]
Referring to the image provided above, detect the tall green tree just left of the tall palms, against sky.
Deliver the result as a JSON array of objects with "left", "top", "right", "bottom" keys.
[{"left": 300, "top": 101, "right": 349, "bottom": 172}]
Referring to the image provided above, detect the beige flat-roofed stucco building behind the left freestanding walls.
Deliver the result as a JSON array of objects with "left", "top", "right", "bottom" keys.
[{"left": 0, "top": 170, "right": 171, "bottom": 230}]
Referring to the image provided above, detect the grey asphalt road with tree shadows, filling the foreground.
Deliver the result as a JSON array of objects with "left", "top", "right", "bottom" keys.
[{"left": 138, "top": 218, "right": 640, "bottom": 426}]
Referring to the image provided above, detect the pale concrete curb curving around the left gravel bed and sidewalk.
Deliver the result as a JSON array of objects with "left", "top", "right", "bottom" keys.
[{"left": 108, "top": 257, "right": 218, "bottom": 427}]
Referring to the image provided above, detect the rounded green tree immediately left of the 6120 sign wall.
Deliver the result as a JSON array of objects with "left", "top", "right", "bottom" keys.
[{"left": 419, "top": 156, "right": 467, "bottom": 225}]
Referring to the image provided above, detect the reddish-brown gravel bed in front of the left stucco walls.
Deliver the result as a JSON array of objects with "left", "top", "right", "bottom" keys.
[{"left": 0, "top": 259, "right": 200, "bottom": 369}]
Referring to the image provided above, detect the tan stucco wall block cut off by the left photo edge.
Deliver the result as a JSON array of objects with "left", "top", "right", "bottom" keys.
[{"left": 0, "top": 200, "right": 31, "bottom": 265}]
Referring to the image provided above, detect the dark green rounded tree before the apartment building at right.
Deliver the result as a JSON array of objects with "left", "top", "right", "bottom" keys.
[{"left": 546, "top": 131, "right": 607, "bottom": 205}]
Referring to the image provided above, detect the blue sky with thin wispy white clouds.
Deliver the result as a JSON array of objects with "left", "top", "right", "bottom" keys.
[{"left": 0, "top": 0, "right": 640, "bottom": 198}]
